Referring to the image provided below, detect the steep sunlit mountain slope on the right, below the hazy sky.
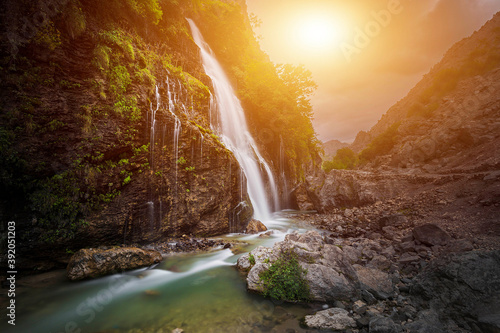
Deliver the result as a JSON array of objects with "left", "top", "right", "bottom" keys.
[{"left": 351, "top": 13, "right": 500, "bottom": 170}]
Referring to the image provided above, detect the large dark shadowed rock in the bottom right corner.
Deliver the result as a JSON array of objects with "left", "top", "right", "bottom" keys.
[{"left": 410, "top": 250, "right": 500, "bottom": 332}]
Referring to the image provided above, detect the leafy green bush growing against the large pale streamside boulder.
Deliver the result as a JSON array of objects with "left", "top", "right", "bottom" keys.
[{"left": 259, "top": 250, "right": 310, "bottom": 301}]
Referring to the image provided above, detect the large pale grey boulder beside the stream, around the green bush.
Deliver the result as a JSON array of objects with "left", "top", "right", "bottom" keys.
[{"left": 237, "top": 231, "right": 359, "bottom": 302}]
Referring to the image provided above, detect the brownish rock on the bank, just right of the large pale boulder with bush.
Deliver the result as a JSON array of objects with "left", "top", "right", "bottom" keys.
[{"left": 354, "top": 265, "right": 394, "bottom": 299}]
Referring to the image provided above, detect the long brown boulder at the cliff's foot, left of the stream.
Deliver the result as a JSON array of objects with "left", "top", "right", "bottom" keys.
[{"left": 66, "top": 247, "right": 162, "bottom": 280}]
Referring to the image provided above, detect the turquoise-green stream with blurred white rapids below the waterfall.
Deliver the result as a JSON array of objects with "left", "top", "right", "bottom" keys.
[{"left": 2, "top": 211, "right": 324, "bottom": 333}]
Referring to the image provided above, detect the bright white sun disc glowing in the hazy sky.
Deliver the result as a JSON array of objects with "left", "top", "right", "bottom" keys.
[{"left": 294, "top": 15, "right": 346, "bottom": 49}]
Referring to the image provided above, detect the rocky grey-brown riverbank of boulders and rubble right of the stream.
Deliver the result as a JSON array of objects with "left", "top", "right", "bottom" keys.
[{"left": 238, "top": 230, "right": 500, "bottom": 332}]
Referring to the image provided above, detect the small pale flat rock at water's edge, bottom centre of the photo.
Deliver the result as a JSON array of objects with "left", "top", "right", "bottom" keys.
[{"left": 305, "top": 308, "right": 356, "bottom": 331}]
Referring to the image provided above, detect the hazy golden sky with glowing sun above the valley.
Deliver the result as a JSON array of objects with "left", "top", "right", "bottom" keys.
[{"left": 246, "top": 0, "right": 500, "bottom": 141}]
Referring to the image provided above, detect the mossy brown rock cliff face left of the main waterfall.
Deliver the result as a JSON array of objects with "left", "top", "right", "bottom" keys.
[{"left": 0, "top": 0, "right": 252, "bottom": 266}]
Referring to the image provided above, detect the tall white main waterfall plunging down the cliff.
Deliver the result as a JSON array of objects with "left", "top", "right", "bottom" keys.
[{"left": 187, "top": 19, "right": 279, "bottom": 221}]
